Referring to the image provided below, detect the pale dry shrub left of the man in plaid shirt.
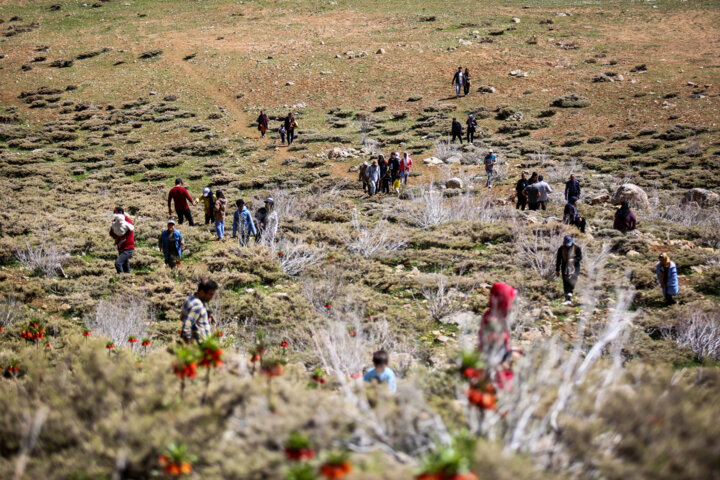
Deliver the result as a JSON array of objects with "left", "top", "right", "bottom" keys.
[{"left": 85, "top": 295, "right": 154, "bottom": 347}]
